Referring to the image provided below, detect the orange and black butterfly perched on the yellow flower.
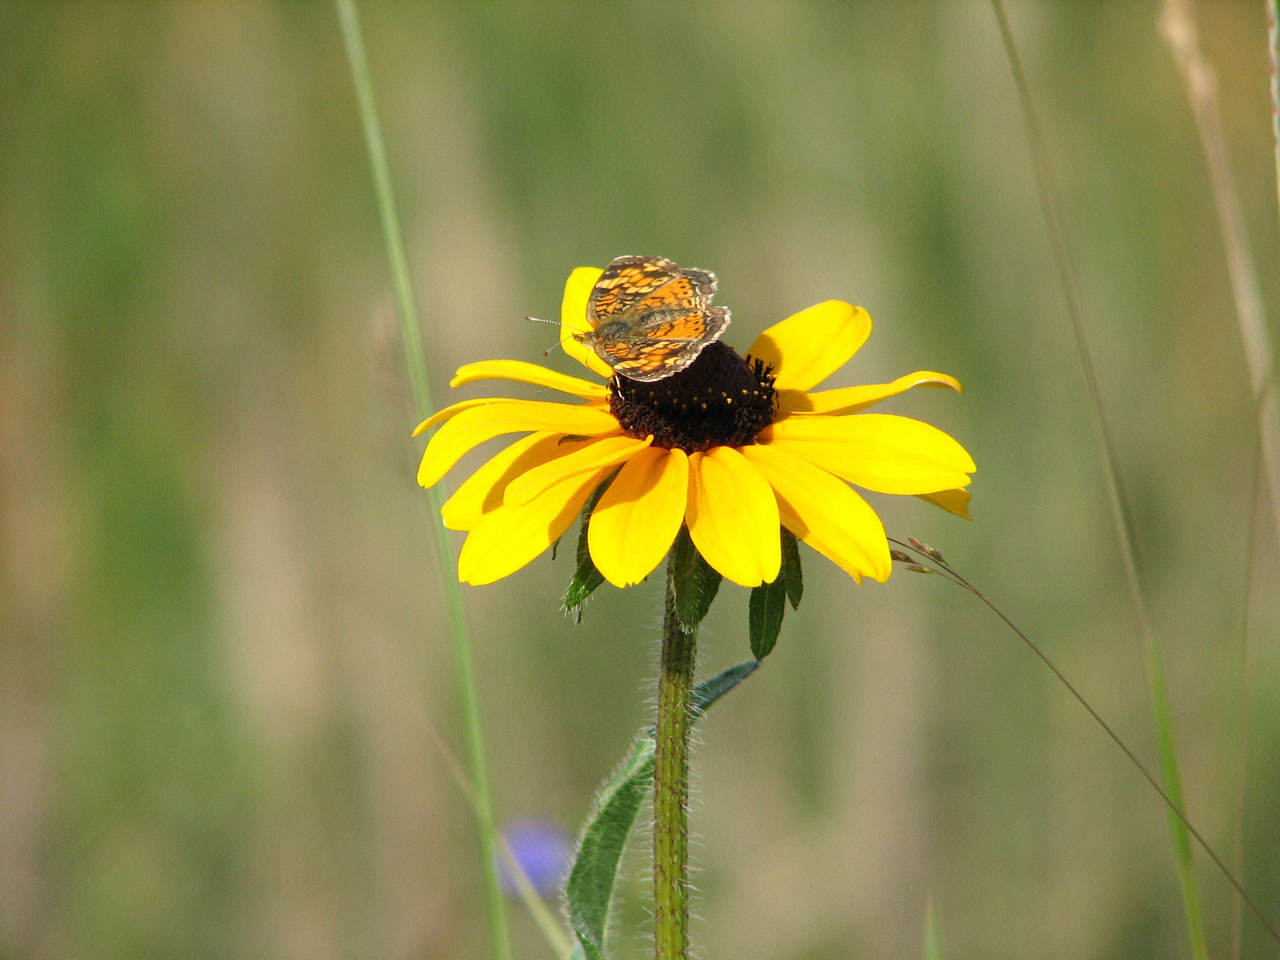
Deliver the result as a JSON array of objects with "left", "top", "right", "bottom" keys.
[{"left": 573, "top": 257, "right": 730, "bottom": 383}]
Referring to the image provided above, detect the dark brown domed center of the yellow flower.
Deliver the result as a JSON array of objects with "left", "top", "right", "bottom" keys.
[{"left": 609, "top": 340, "right": 777, "bottom": 453}]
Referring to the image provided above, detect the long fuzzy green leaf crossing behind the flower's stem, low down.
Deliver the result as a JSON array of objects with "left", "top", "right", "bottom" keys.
[{"left": 564, "top": 660, "right": 759, "bottom": 960}]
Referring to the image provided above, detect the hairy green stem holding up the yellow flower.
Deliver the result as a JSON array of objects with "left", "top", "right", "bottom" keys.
[{"left": 653, "top": 559, "right": 698, "bottom": 960}]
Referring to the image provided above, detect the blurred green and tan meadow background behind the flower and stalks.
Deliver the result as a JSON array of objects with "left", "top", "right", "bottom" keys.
[{"left": 0, "top": 0, "right": 1280, "bottom": 960}]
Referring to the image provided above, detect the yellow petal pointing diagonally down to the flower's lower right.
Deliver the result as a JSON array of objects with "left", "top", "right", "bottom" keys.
[{"left": 742, "top": 444, "right": 892, "bottom": 584}]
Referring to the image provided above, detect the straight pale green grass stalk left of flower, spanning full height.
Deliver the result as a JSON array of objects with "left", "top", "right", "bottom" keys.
[{"left": 334, "top": 0, "right": 511, "bottom": 960}]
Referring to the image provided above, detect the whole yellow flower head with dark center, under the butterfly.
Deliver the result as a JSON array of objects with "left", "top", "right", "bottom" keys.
[{"left": 415, "top": 268, "right": 977, "bottom": 586}]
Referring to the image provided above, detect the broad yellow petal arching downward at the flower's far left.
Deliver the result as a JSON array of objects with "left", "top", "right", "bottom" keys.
[{"left": 417, "top": 401, "right": 619, "bottom": 486}]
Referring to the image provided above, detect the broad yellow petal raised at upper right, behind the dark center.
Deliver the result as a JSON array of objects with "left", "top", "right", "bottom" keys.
[{"left": 748, "top": 300, "right": 872, "bottom": 390}]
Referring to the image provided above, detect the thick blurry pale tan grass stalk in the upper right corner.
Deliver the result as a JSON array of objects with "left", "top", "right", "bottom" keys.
[{"left": 1160, "top": 0, "right": 1280, "bottom": 547}]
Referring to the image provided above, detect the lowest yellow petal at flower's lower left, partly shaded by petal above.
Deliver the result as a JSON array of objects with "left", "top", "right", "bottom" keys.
[{"left": 458, "top": 467, "right": 611, "bottom": 586}]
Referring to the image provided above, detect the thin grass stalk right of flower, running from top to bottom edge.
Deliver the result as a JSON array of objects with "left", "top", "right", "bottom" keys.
[{"left": 991, "top": 0, "right": 1208, "bottom": 960}]
